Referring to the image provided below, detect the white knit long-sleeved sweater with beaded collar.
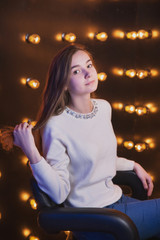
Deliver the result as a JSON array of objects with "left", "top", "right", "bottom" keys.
[{"left": 30, "top": 99, "right": 134, "bottom": 207}]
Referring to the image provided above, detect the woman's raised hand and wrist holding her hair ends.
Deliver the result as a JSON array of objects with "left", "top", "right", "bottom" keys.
[{"left": 13, "top": 122, "right": 41, "bottom": 163}]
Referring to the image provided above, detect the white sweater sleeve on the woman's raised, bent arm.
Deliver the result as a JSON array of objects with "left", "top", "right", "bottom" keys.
[{"left": 30, "top": 122, "right": 70, "bottom": 204}]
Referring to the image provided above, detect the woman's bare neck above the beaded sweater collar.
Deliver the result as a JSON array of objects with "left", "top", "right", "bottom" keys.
[{"left": 68, "top": 97, "right": 93, "bottom": 114}]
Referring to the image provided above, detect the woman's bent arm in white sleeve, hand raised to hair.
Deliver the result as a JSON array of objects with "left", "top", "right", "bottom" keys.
[{"left": 13, "top": 123, "right": 70, "bottom": 204}]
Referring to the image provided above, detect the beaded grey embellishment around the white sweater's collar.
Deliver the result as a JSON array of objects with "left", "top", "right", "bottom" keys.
[{"left": 65, "top": 100, "right": 98, "bottom": 119}]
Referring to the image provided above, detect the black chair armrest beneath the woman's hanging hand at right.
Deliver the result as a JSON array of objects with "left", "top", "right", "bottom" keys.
[{"left": 113, "top": 171, "right": 148, "bottom": 200}]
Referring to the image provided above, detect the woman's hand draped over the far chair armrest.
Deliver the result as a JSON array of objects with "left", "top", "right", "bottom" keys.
[{"left": 134, "top": 162, "right": 154, "bottom": 196}]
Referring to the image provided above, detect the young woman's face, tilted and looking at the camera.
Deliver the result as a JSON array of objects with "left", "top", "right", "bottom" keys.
[{"left": 68, "top": 50, "right": 98, "bottom": 97}]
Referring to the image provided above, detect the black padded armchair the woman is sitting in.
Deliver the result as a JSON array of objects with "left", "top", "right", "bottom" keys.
[{"left": 31, "top": 171, "right": 147, "bottom": 240}]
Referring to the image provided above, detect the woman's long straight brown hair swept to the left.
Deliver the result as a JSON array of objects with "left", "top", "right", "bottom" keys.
[{"left": 34, "top": 44, "right": 92, "bottom": 130}]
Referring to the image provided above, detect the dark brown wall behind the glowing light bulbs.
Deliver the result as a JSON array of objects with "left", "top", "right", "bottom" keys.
[{"left": 0, "top": 0, "right": 160, "bottom": 240}]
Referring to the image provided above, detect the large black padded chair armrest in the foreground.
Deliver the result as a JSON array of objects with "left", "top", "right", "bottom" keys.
[{"left": 38, "top": 207, "right": 139, "bottom": 240}]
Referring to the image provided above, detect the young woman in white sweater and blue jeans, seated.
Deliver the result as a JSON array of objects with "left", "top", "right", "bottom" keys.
[{"left": 10, "top": 44, "right": 160, "bottom": 240}]
